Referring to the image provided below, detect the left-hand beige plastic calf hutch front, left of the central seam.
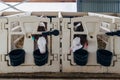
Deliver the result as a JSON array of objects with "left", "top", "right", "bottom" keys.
[{"left": 2, "top": 13, "right": 60, "bottom": 73}]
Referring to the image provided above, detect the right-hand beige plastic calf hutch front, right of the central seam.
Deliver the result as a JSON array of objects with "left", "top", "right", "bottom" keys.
[{"left": 62, "top": 16, "right": 113, "bottom": 73}]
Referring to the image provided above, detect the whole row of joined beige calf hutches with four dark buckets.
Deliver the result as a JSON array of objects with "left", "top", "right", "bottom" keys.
[{"left": 0, "top": 12, "right": 120, "bottom": 73}]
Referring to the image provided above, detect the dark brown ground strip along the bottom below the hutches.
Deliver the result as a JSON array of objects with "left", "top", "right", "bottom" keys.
[{"left": 0, "top": 72, "right": 120, "bottom": 80}]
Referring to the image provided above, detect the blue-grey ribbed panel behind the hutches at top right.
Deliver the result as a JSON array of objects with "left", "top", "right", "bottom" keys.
[{"left": 77, "top": 0, "right": 120, "bottom": 13}]
